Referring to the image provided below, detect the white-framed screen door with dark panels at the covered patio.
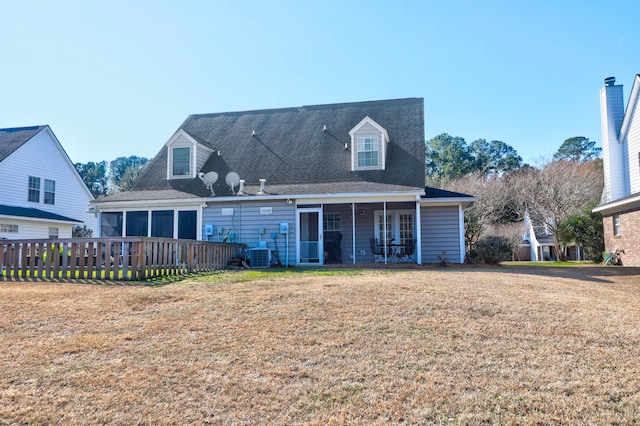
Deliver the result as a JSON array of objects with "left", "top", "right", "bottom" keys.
[{"left": 297, "top": 208, "right": 324, "bottom": 265}]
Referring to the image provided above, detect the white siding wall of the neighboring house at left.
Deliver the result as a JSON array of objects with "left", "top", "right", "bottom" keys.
[{"left": 0, "top": 129, "right": 97, "bottom": 238}]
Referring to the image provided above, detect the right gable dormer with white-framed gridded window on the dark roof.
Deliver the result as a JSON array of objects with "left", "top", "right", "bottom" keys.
[{"left": 349, "top": 116, "right": 389, "bottom": 171}]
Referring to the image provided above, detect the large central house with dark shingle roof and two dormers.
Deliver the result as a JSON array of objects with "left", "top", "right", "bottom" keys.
[{"left": 92, "top": 98, "right": 475, "bottom": 265}]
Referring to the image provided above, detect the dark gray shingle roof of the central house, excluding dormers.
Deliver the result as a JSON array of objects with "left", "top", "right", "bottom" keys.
[{"left": 102, "top": 98, "right": 425, "bottom": 201}]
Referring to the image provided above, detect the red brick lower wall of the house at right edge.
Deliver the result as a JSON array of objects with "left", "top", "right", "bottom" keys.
[{"left": 602, "top": 209, "right": 640, "bottom": 266}]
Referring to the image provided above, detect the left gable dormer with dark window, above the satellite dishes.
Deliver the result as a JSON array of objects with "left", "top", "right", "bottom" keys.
[{"left": 165, "top": 129, "right": 213, "bottom": 179}]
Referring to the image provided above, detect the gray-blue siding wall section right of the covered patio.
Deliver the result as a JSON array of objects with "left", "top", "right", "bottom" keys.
[{"left": 421, "top": 206, "right": 461, "bottom": 263}]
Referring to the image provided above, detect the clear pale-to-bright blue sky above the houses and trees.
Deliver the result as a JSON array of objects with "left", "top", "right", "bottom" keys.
[{"left": 0, "top": 0, "right": 640, "bottom": 163}]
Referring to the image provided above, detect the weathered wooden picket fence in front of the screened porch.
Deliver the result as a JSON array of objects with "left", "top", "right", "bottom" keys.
[{"left": 0, "top": 237, "right": 244, "bottom": 281}]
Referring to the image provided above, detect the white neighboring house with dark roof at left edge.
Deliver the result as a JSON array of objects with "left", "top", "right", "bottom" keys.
[{"left": 0, "top": 125, "right": 97, "bottom": 239}]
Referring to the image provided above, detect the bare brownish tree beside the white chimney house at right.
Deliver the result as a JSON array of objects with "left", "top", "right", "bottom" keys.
[{"left": 509, "top": 160, "right": 603, "bottom": 259}]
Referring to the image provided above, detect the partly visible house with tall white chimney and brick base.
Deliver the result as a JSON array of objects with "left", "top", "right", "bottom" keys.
[{"left": 593, "top": 74, "right": 640, "bottom": 266}]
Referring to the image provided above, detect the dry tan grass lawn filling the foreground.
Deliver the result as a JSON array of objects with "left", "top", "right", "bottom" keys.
[{"left": 0, "top": 267, "right": 640, "bottom": 425}]
